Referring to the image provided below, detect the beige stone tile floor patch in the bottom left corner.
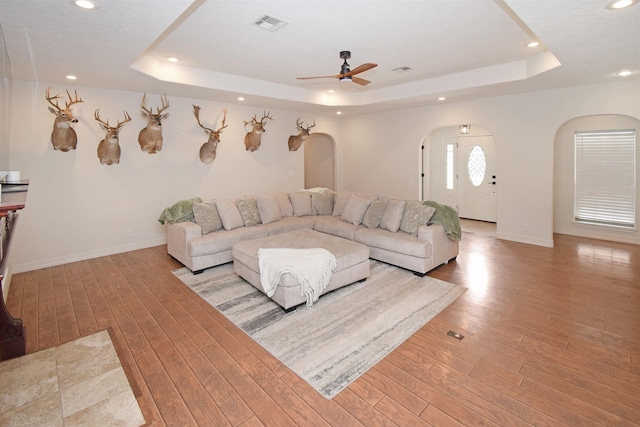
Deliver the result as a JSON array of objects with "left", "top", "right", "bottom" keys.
[{"left": 0, "top": 330, "right": 145, "bottom": 427}]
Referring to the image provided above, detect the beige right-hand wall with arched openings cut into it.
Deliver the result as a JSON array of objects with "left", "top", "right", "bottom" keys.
[{"left": 338, "top": 79, "right": 640, "bottom": 246}]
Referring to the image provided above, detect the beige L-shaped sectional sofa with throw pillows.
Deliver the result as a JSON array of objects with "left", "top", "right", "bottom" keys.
[{"left": 167, "top": 190, "right": 459, "bottom": 275}]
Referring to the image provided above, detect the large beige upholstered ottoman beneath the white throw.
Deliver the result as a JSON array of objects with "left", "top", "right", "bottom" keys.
[{"left": 231, "top": 230, "right": 370, "bottom": 310}]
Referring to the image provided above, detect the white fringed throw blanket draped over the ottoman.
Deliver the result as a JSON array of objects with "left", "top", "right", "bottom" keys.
[{"left": 258, "top": 248, "right": 336, "bottom": 306}]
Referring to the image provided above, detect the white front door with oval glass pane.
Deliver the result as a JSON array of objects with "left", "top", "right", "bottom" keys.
[{"left": 457, "top": 136, "right": 497, "bottom": 222}]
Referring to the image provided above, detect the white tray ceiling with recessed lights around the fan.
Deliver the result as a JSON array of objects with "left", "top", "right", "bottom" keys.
[{"left": 0, "top": 0, "right": 640, "bottom": 114}]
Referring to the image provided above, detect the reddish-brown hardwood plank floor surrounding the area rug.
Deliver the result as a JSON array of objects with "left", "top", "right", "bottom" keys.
[{"left": 8, "top": 233, "right": 640, "bottom": 427}]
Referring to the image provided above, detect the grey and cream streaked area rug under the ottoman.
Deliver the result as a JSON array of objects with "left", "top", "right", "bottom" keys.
[{"left": 173, "top": 260, "right": 466, "bottom": 399}]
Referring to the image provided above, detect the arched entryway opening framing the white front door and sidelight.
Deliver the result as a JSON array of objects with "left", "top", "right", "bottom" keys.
[{"left": 421, "top": 125, "right": 498, "bottom": 227}]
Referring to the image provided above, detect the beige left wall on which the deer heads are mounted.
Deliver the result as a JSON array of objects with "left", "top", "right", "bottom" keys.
[{"left": 9, "top": 81, "right": 337, "bottom": 272}]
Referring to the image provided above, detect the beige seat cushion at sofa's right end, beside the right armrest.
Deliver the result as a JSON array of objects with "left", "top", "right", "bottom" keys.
[{"left": 355, "top": 227, "right": 432, "bottom": 258}]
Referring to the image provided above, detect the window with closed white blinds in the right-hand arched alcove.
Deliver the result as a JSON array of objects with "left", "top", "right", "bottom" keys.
[{"left": 574, "top": 130, "right": 636, "bottom": 228}]
